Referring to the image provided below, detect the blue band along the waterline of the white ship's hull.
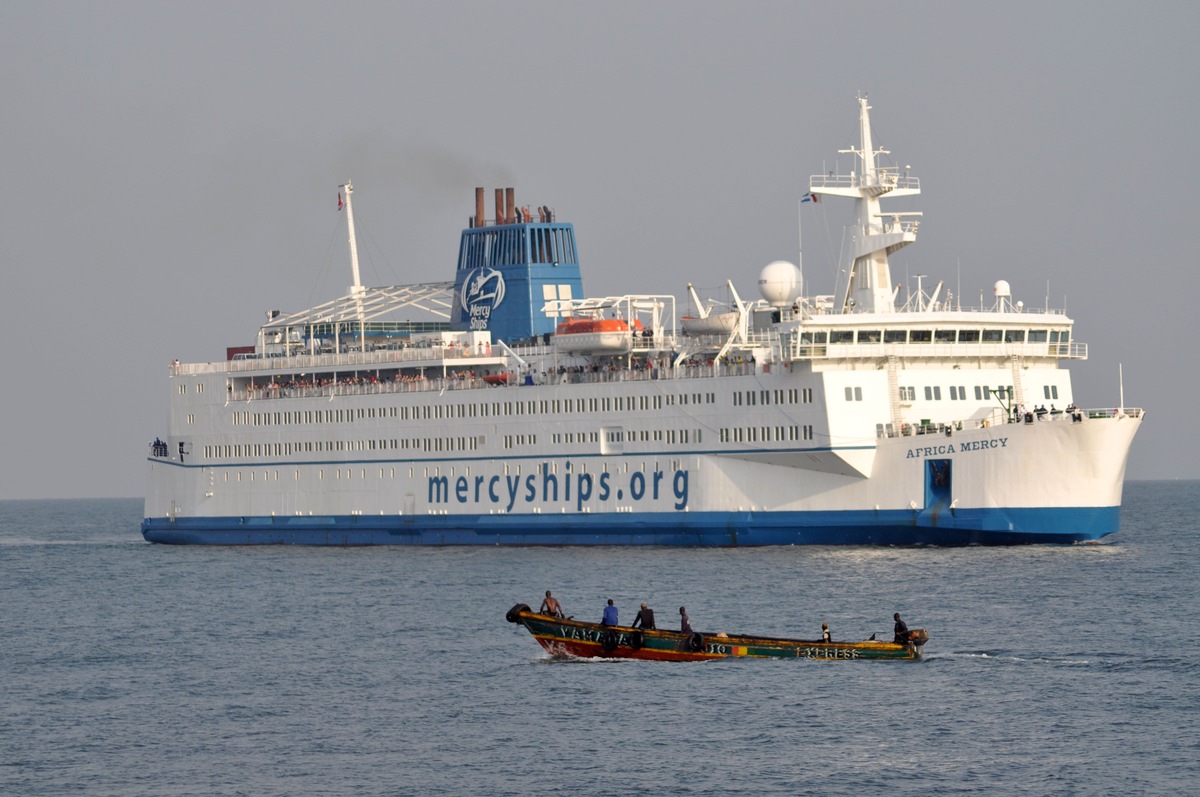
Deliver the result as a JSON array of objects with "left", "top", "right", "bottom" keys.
[{"left": 142, "top": 507, "right": 1120, "bottom": 547}]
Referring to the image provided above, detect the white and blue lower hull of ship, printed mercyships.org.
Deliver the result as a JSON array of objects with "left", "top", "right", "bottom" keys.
[{"left": 142, "top": 400, "right": 1141, "bottom": 547}]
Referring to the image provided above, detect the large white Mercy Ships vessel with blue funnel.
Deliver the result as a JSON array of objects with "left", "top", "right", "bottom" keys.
[{"left": 142, "top": 91, "right": 1144, "bottom": 546}]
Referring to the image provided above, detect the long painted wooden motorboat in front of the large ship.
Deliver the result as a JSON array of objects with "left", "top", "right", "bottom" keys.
[{"left": 505, "top": 604, "right": 929, "bottom": 661}]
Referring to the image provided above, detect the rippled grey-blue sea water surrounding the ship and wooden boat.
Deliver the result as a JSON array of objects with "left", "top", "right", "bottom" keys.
[{"left": 0, "top": 483, "right": 1200, "bottom": 796}]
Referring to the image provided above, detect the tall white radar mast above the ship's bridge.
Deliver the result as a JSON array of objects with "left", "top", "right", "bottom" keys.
[{"left": 810, "top": 96, "right": 920, "bottom": 313}]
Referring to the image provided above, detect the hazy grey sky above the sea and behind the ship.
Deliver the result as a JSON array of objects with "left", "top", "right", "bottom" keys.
[{"left": 0, "top": 0, "right": 1200, "bottom": 498}]
